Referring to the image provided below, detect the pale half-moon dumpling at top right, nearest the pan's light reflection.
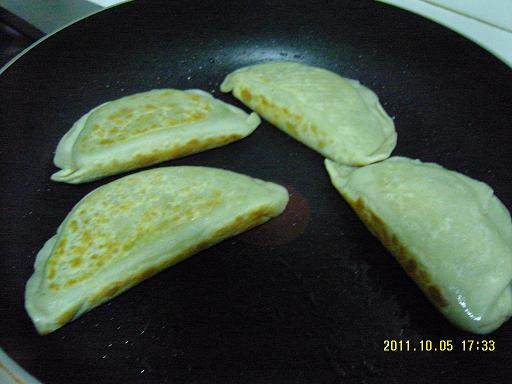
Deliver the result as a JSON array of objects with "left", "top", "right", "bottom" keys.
[{"left": 220, "top": 61, "right": 396, "bottom": 165}]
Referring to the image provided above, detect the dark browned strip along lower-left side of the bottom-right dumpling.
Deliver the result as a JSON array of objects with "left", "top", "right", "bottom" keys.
[{"left": 347, "top": 198, "right": 448, "bottom": 308}]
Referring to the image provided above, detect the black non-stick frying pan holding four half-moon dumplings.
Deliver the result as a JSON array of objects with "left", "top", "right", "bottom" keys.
[{"left": 0, "top": 0, "right": 512, "bottom": 383}]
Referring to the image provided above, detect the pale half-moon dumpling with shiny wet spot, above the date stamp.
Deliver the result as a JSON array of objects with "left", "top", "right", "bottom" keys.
[{"left": 326, "top": 157, "right": 512, "bottom": 333}]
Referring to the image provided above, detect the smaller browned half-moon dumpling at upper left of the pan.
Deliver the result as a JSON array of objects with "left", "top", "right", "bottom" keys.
[{"left": 52, "top": 89, "right": 260, "bottom": 184}]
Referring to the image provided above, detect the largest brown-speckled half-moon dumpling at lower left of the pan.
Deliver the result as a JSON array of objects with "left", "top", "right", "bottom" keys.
[{"left": 25, "top": 167, "right": 288, "bottom": 334}]
